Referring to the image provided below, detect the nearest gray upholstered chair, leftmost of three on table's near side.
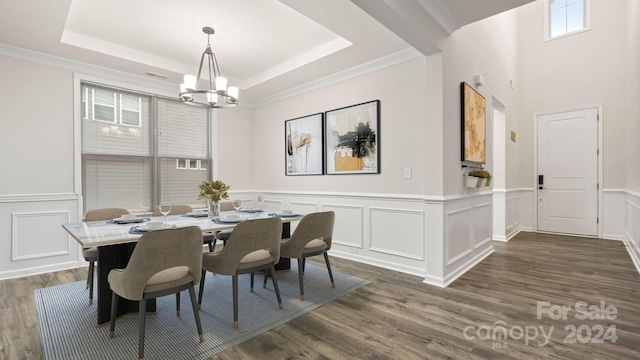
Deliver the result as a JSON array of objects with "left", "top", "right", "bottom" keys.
[{"left": 108, "top": 226, "right": 204, "bottom": 359}]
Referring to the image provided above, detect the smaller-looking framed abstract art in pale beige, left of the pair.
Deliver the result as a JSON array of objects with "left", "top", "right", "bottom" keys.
[{"left": 284, "top": 113, "right": 324, "bottom": 175}]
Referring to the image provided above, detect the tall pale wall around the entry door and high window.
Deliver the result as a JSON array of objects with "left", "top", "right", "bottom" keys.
[{"left": 517, "top": 0, "right": 637, "bottom": 189}]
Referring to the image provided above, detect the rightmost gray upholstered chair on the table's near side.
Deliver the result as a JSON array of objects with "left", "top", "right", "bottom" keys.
[{"left": 278, "top": 211, "right": 336, "bottom": 301}]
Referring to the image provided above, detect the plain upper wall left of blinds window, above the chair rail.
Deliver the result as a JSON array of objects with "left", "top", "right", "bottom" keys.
[{"left": 0, "top": 55, "right": 74, "bottom": 195}]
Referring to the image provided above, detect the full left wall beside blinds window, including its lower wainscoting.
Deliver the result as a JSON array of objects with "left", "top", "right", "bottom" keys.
[{"left": 0, "top": 55, "right": 79, "bottom": 279}]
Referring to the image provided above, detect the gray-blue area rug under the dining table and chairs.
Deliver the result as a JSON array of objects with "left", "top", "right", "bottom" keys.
[{"left": 34, "top": 260, "right": 369, "bottom": 360}]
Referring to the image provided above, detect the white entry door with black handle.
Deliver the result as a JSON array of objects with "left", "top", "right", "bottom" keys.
[{"left": 536, "top": 108, "right": 598, "bottom": 236}]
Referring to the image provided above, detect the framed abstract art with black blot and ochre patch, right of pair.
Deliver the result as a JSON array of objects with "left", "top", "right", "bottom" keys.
[{"left": 324, "top": 100, "right": 380, "bottom": 175}]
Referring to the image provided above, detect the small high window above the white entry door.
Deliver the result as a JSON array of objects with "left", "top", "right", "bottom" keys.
[{"left": 544, "top": 0, "right": 591, "bottom": 41}]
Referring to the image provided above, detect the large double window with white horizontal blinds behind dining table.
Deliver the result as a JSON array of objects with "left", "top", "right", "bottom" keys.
[{"left": 81, "top": 84, "right": 210, "bottom": 210}]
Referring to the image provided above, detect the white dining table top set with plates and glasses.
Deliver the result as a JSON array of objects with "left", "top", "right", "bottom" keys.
[{"left": 62, "top": 209, "right": 303, "bottom": 247}]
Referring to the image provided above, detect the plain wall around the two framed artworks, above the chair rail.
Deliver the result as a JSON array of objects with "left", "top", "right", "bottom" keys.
[{"left": 254, "top": 57, "right": 441, "bottom": 194}]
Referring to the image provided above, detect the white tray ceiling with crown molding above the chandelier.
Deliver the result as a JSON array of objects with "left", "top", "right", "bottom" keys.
[{"left": 0, "top": 0, "right": 533, "bottom": 101}]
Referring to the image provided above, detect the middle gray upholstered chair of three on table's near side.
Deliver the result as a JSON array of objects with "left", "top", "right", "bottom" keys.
[{"left": 198, "top": 218, "right": 282, "bottom": 329}]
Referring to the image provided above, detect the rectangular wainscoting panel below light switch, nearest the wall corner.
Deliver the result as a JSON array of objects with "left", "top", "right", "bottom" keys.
[{"left": 369, "top": 207, "right": 424, "bottom": 260}]
